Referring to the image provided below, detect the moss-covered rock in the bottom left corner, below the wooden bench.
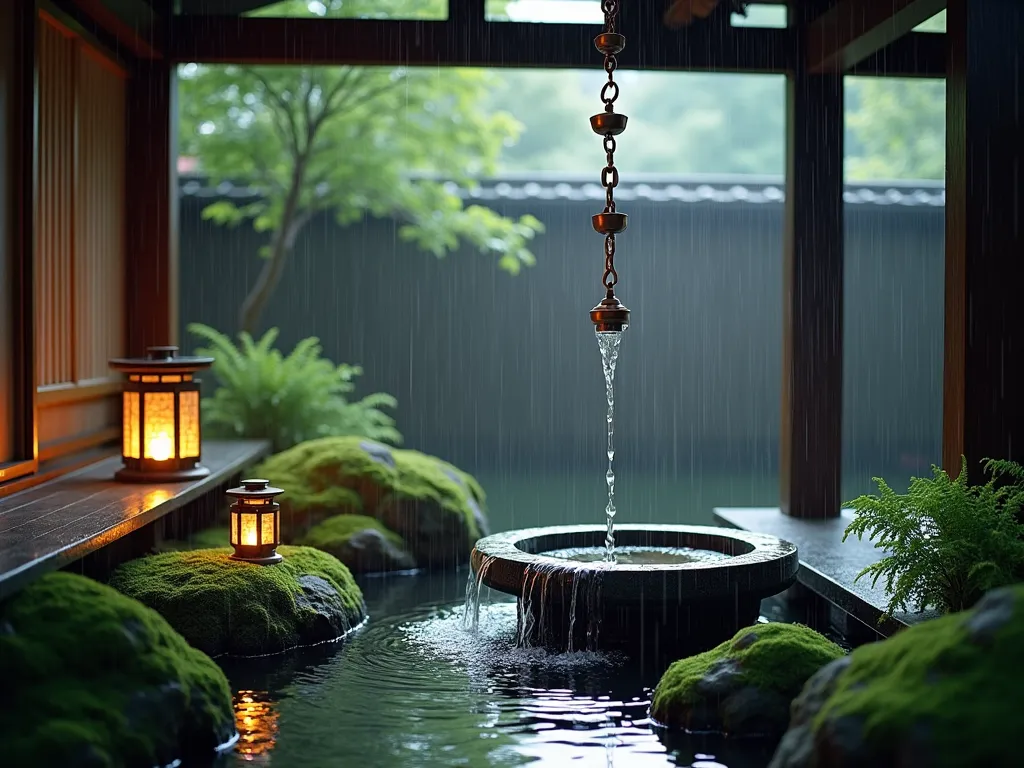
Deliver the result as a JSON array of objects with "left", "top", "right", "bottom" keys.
[{"left": 0, "top": 572, "right": 234, "bottom": 768}]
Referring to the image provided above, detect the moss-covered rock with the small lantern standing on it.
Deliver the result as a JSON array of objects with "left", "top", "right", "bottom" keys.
[{"left": 110, "top": 546, "right": 366, "bottom": 655}]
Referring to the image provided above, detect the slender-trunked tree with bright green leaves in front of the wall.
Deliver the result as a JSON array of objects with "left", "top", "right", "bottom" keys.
[{"left": 178, "top": 0, "right": 543, "bottom": 333}]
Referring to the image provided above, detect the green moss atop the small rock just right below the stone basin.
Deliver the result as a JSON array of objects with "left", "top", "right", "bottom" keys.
[{"left": 651, "top": 623, "right": 845, "bottom": 723}]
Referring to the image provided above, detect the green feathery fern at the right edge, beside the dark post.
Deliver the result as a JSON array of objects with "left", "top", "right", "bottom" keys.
[{"left": 843, "top": 459, "right": 1024, "bottom": 614}]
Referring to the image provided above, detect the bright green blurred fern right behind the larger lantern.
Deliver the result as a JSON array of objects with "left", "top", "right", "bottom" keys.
[{"left": 188, "top": 323, "right": 401, "bottom": 452}]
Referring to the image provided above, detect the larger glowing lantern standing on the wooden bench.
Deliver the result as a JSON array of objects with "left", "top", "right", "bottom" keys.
[{"left": 110, "top": 347, "right": 213, "bottom": 482}]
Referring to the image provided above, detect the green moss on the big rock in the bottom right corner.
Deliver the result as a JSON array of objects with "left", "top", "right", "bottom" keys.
[{"left": 814, "top": 585, "right": 1024, "bottom": 768}]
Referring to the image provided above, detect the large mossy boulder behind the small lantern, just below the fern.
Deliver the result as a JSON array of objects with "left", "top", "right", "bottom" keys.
[{"left": 256, "top": 437, "right": 487, "bottom": 566}]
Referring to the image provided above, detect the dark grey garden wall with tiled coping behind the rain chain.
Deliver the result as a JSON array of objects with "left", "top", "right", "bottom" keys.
[{"left": 180, "top": 177, "right": 943, "bottom": 483}]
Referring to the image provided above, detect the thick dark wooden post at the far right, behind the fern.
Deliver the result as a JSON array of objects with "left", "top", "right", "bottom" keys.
[{"left": 942, "top": 0, "right": 1024, "bottom": 479}]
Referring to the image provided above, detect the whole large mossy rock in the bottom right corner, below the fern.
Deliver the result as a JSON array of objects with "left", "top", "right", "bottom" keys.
[{"left": 771, "top": 585, "right": 1024, "bottom": 768}]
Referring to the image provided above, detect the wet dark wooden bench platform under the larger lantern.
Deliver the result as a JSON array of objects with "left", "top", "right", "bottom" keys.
[{"left": 0, "top": 440, "right": 270, "bottom": 599}]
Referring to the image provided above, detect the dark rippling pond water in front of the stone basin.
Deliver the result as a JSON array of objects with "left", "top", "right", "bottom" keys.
[{"left": 218, "top": 570, "right": 806, "bottom": 768}]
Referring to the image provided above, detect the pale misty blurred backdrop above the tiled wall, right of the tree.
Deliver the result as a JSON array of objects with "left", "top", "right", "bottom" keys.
[{"left": 489, "top": 70, "right": 945, "bottom": 179}]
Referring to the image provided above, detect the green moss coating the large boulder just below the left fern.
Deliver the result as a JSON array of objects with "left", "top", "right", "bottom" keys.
[{"left": 256, "top": 437, "right": 485, "bottom": 554}]
